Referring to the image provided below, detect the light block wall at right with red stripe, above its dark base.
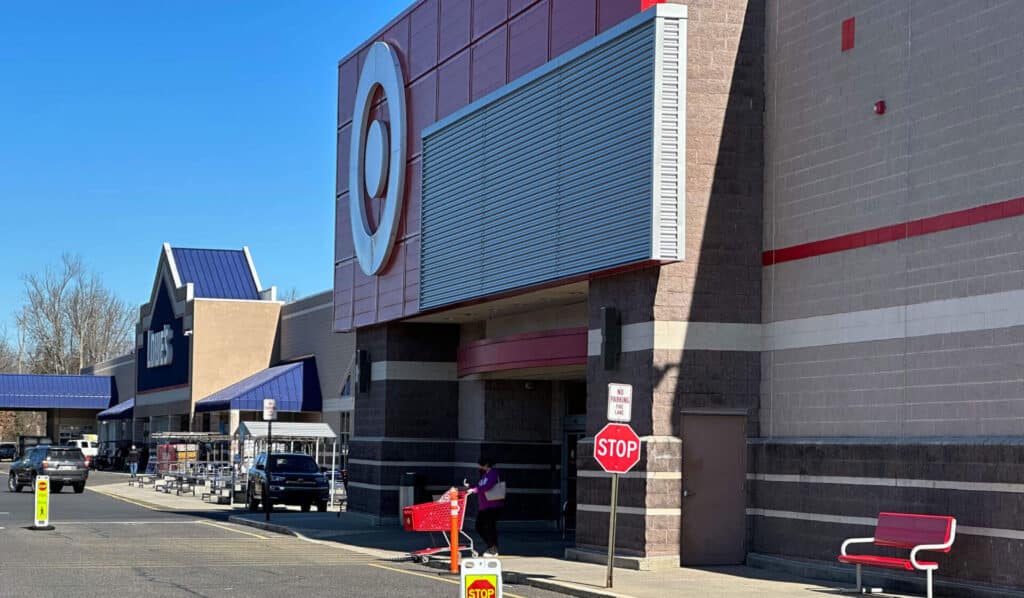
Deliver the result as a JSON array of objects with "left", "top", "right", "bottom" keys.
[{"left": 761, "top": 0, "right": 1024, "bottom": 436}]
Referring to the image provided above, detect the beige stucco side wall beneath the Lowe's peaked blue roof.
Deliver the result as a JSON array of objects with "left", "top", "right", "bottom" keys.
[{"left": 191, "top": 299, "right": 282, "bottom": 405}]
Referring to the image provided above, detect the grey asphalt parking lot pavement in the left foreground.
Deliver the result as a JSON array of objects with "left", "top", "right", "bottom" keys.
[{"left": 0, "top": 466, "right": 569, "bottom": 598}]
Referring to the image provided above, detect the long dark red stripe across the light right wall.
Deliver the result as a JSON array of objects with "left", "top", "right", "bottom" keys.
[{"left": 761, "top": 198, "right": 1024, "bottom": 266}]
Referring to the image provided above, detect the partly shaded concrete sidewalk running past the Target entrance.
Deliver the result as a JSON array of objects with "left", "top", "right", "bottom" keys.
[{"left": 228, "top": 513, "right": 839, "bottom": 598}]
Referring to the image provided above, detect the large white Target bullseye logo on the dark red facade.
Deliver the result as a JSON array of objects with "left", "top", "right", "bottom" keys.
[{"left": 348, "top": 42, "right": 407, "bottom": 275}]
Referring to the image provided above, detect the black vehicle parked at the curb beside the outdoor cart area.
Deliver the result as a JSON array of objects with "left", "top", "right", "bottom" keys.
[{"left": 246, "top": 453, "right": 331, "bottom": 512}]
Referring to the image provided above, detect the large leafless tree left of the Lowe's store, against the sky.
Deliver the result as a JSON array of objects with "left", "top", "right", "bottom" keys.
[{"left": 16, "top": 254, "right": 134, "bottom": 374}]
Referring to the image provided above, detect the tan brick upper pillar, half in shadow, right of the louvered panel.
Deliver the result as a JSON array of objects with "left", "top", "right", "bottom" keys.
[{"left": 653, "top": 0, "right": 765, "bottom": 323}]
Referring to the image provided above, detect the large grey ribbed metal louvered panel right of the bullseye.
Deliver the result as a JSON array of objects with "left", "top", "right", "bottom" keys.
[{"left": 420, "top": 9, "right": 685, "bottom": 308}]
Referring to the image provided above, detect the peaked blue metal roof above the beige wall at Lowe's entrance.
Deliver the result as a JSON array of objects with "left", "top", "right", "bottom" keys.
[{"left": 171, "top": 247, "right": 259, "bottom": 299}]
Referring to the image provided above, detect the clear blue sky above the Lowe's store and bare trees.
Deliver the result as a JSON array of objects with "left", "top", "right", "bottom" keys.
[{"left": 0, "top": 0, "right": 410, "bottom": 332}]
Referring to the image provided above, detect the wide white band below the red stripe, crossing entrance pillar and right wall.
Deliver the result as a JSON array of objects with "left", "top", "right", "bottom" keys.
[{"left": 587, "top": 290, "right": 1024, "bottom": 356}]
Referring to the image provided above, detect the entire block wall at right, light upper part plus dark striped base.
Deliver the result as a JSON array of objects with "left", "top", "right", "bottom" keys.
[{"left": 761, "top": 0, "right": 1024, "bottom": 595}]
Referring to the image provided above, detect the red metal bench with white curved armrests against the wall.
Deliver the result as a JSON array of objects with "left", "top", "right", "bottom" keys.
[{"left": 839, "top": 513, "right": 956, "bottom": 598}]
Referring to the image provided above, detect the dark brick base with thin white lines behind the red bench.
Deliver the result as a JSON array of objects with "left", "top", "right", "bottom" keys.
[{"left": 749, "top": 438, "right": 1024, "bottom": 596}]
